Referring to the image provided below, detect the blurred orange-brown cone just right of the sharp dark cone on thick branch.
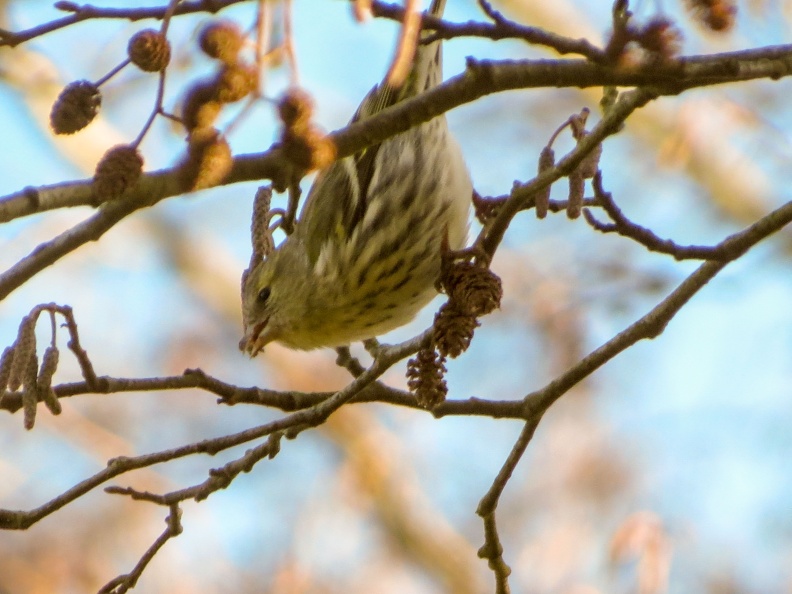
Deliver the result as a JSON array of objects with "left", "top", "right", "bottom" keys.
[{"left": 180, "top": 128, "right": 234, "bottom": 191}]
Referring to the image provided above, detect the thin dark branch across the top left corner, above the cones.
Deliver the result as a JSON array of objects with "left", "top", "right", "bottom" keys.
[{"left": 0, "top": 0, "right": 251, "bottom": 47}]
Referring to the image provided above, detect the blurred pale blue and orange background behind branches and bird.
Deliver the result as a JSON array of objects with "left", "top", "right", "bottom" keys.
[{"left": 0, "top": 0, "right": 792, "bottom": 594}]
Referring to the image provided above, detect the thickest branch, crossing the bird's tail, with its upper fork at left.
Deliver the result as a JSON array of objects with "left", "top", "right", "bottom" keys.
[{"left": 0, "top": 45, "right": 792, "bottom": 227}]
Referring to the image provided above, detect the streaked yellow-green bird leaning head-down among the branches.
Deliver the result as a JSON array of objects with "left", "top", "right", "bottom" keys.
[{"left": 242, "top": 0, "right": 472, "bottom": 355}]
